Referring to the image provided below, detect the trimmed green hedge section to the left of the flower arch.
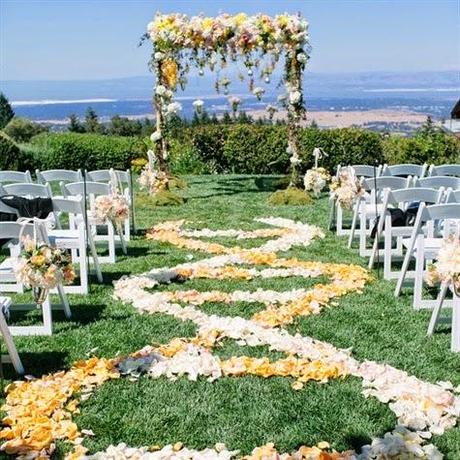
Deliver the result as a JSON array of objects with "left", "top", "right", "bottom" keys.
[{"left": 32, "top": 133, "right": 145, "bottom": 170}]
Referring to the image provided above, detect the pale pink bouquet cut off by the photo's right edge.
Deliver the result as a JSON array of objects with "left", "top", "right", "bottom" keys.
[{"left": 426, "top": 236, "right": 460, "bottom": 296}]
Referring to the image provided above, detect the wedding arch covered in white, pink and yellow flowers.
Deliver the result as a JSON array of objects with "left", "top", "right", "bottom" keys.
[{"left": 144, "top": 13, "right": 309, "bottom": 192}]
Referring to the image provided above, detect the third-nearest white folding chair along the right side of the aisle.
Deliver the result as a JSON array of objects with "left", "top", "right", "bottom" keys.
[{"left": 369, "top": 187, "right": 443, "bottom": 280}]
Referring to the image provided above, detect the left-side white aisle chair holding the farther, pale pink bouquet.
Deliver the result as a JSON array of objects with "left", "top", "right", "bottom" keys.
[{"left": 61, "top": 181, "right": 123, "bottom": 263}]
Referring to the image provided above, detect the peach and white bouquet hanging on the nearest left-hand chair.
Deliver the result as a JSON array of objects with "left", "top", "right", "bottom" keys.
[{"left": 15, "top": 236, "right": 75, "bottom": 304}]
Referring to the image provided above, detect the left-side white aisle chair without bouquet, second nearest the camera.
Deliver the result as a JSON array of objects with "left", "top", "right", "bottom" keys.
[{"left": 48, "top": 197, "right": 103, "bottom": 294}]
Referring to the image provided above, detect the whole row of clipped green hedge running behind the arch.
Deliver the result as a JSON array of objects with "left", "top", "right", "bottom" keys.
[{"left": 12, "top": 123, "right": 460, "bottom": 174}]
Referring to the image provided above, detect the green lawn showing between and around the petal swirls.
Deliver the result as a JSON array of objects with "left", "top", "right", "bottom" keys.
[{"left": 0, "top": 176, "right": 460, "bottom": 459}]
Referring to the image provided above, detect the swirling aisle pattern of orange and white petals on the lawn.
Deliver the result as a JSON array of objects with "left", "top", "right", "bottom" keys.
[{"left": 0, "top": 218, "right": 460, "bottom": 460}]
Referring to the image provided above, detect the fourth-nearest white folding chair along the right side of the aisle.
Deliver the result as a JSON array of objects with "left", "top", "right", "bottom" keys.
[{"left": 348, "top": 176, "right": 411, "bottom": 257}]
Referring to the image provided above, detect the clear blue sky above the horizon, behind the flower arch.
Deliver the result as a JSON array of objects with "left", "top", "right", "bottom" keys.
[{"left": 0, "top": 0, "right": 460, "bottom": 80}]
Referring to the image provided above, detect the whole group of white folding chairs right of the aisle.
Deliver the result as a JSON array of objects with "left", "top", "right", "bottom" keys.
[{"left": 333, "top": 165, "right": 460, "bottom": 351}]
